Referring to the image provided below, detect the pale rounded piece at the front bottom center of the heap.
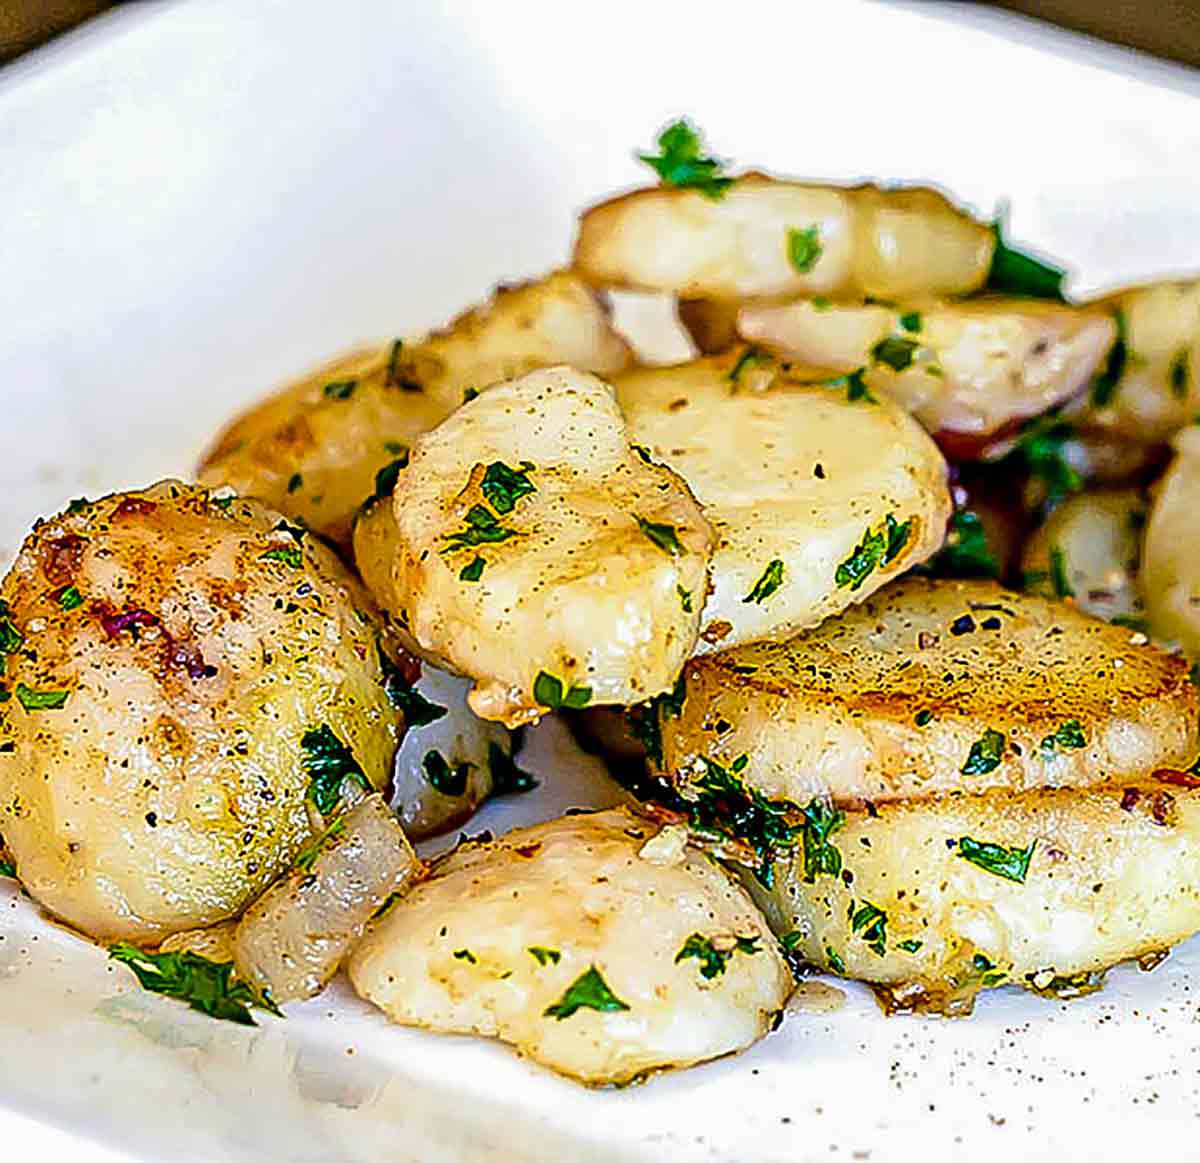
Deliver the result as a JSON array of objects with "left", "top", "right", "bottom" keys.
[{"left": 348, "top": 808, "right": 792, "bottom": 1084}]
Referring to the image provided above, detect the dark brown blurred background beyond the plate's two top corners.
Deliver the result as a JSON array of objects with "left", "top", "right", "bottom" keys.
[{"left": 7, "top": 0, "right": 1200, "bottom": 67}]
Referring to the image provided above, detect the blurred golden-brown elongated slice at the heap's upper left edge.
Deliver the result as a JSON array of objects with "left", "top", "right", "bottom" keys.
[{"left": 199, "top": 271, "right": 630, "bottom": 546}]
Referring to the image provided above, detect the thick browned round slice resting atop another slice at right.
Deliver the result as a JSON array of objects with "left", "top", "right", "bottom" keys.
[{"left": 661, "top": 578, "right": 1198, "bottom": 804}]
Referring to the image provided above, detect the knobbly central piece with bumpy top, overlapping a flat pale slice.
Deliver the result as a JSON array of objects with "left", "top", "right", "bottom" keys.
[{"left": 373, "top": 367, "right": 713, "bottom": 726}]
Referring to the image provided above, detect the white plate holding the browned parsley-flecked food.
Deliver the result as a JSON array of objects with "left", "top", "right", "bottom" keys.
[{"left": 7, "top": 0, "right": 1200, "bottom": 1163}]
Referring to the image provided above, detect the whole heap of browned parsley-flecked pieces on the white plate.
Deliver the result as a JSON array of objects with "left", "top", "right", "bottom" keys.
[{"left": 7, "top": 120, "right": 1200, "bottom": 1086}]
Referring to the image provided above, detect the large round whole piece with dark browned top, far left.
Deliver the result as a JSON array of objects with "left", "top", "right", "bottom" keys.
[{"left": 0, "top": 481, "right": 398, "bottom": 943}]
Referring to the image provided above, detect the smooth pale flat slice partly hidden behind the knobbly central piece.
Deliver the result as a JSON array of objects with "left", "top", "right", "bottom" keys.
[{"left": 616, "top": 349, "right": 950, "bottom": 653}]
